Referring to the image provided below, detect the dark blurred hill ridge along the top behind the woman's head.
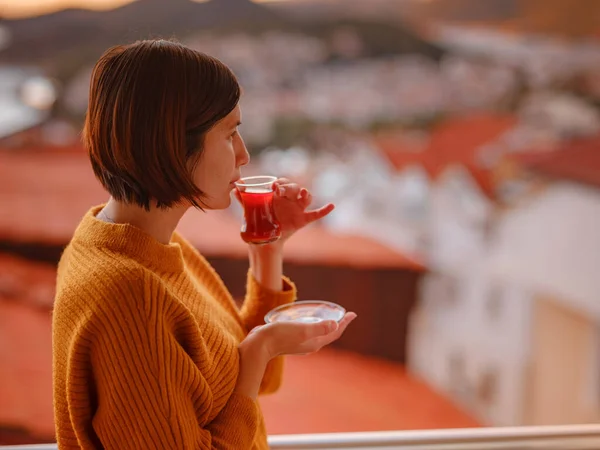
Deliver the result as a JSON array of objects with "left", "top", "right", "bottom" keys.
[{"left": 0, "top": 0, "right": 443, "bottom": 76}]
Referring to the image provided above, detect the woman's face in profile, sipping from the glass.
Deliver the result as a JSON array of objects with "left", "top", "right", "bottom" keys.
[{"left": 194, "top": 105, "right": 250, "bottom": 209}]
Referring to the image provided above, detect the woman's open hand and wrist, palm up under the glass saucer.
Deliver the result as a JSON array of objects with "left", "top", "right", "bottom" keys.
[{"left": 235, "top": 312, "right": 356, "bottom": 399}]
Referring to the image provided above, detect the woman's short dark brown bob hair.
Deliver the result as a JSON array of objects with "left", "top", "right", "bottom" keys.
[{"left": 83, "top": 40, "right": 240, "bottom": 209}]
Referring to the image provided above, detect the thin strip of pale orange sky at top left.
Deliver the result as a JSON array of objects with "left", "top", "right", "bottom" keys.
[{"left": 0, "top": 0, "right": 284, "bottom": 18}]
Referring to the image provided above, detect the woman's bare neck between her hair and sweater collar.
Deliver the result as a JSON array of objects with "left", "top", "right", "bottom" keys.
[{"left": 99, "top": 197, "right": 188, "bottom": 245}]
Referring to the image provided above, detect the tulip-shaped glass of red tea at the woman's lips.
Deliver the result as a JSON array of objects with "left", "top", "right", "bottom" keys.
[{"left": 236, "top": 176, "right": 281, "bottom": 244}]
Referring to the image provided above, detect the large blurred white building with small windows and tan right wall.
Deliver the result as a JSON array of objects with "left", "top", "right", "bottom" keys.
[{"left": 409, "top": 142, "right": 600, "bottom": 426}]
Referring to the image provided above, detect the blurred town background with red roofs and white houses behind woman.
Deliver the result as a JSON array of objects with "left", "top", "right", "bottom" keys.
[{"left": 0, "top": 0, "right": 600, "bottom": 443}]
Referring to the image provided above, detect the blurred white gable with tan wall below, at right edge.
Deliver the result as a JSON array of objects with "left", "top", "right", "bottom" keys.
[{"left": 489, "top": 182, "right": 600, "bottom": 424}]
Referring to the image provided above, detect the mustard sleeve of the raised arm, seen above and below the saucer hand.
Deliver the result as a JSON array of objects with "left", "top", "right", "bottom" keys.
[{"left": 241, "top": 271, "right": 297, "bottom": 395}]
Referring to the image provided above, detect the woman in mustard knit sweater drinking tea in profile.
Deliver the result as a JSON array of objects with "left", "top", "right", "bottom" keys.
[{"left": 53, "top": 40, "right": 355, "bottom": 450}]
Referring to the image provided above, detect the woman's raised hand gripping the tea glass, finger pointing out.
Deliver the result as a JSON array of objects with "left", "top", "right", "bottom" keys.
[{"left": 273, "top": 178, "right": 334, "bottom": 243}]
